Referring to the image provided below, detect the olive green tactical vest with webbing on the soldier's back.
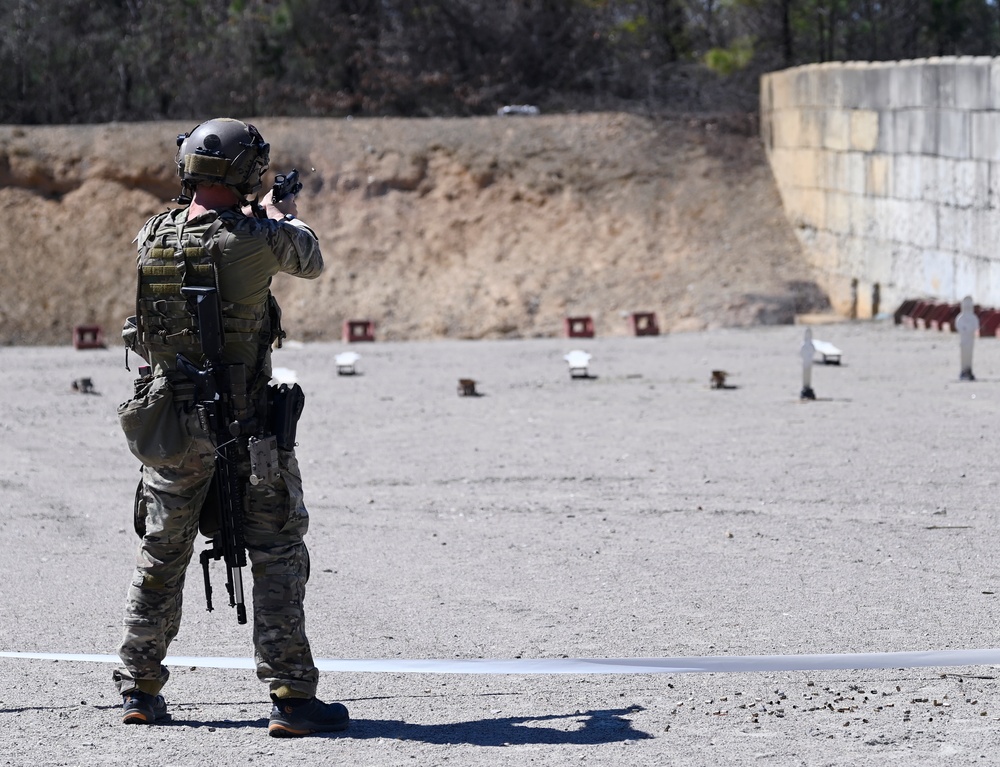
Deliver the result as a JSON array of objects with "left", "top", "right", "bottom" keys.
[{"left": 136, "top": 208, "right": 280, "bottom": 376}]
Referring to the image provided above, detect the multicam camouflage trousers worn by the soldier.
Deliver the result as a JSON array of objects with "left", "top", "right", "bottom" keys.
[{"left": 114, "top": 402, "right": 319, "bottom": 697}]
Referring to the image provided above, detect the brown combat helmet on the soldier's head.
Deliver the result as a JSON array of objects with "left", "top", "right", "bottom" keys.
[{"left": 176, "top": 117, "right": 271, "bottom": 199}]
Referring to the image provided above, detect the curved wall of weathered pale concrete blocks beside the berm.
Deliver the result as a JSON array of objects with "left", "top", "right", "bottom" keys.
[{"left": 761, "top": 57, "right": 1000, "bottom": 317}]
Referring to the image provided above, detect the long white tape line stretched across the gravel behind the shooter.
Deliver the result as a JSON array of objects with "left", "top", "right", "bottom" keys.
[{"left": 0, "top": 649, "right": 1000, "bottom": 674}]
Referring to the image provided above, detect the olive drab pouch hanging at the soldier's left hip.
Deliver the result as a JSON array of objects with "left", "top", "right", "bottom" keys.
[{"left": 118, "top": 375, "right": 191, "bottom": 469}]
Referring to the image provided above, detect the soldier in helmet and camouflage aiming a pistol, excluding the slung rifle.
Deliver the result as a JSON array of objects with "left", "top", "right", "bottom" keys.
[{"left": 114, "top": 118, "right": 349, "bottom": 737}]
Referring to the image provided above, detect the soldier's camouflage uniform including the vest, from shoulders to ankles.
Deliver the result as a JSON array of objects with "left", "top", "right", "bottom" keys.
[{"left": 114, "top": 208, "right": 323, "bottom": 697}]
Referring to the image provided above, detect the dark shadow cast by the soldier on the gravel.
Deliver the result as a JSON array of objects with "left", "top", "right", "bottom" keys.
[{"left": 170, "top": 706, "right": 653, "bottom": 746}]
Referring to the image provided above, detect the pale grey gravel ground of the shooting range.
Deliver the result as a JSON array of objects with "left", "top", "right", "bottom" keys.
[{"left": 0, "top": 322, "right": 1000, "bottom": 766}]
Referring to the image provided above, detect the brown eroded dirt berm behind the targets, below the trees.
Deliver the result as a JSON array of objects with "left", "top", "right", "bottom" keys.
[{"left": 0, "top": 113, "right": 826, "bottom": 345}]
